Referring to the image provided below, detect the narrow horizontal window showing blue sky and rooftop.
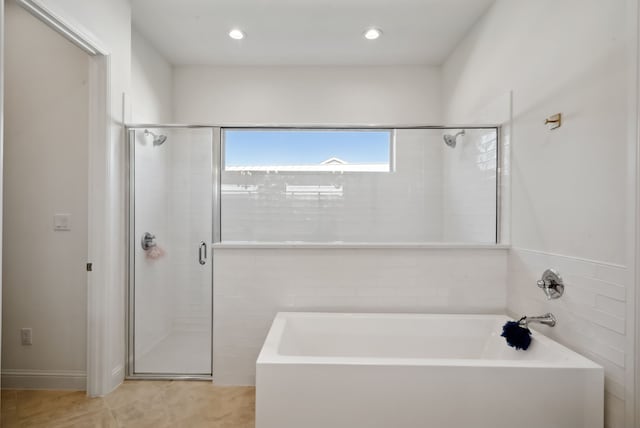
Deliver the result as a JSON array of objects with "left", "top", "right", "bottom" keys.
[{"left": 224, "top": 129, "right": 393, "bottom": 173}]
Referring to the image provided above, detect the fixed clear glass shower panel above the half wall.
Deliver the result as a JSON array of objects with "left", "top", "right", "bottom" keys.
[{"left": 220, "top": 128, "right": 499, "bottom": 243}]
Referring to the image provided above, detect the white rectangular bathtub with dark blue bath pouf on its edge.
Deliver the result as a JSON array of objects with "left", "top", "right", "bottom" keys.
[{"left": 256, "top": 313, "right": 604, "bottom": 428}]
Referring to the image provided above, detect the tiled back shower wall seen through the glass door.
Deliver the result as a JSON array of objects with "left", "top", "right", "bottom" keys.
[{"left": 162, "top": 129, "right": 212, "bottom": 335}]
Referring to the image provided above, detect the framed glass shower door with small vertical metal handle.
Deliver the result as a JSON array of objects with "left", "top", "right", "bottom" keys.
[{"left": 129, "top": 128, "right": 213, "bottom": 376}]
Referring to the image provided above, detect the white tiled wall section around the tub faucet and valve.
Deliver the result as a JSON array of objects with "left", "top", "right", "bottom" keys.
[{"left": 507, "top": 248, "right": 628, "bottom": 427}]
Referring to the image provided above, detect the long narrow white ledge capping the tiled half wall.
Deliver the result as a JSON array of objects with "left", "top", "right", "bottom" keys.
[{"left": 213, "top": 241, "right": 511, "bottom": 250}]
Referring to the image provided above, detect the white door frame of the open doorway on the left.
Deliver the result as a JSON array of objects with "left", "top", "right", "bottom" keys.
[{"left": 14, "top": 0, "right": 114, "bottom": 396}]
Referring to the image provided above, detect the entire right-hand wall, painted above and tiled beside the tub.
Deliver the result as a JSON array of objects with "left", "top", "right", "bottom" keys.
[{"left": 443, "top": 0, "right": 637, "bottom": 427}]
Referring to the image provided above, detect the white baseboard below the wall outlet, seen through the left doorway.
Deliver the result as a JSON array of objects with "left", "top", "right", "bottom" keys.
[{"left": 2, "top": 369, "right": 87, "bottom": 391}]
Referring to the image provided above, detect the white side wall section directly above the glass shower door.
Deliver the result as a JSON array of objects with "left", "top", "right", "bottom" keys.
[{"left": 131, "top": 29, "right": 173, "bottom": 123}]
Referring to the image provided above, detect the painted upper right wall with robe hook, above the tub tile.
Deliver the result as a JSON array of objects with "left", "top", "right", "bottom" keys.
[{"left": 443, "top": 0, "right": 629, "bottom": 263}]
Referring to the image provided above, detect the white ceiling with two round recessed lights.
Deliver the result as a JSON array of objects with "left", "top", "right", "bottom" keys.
[{"left": 132, "top": 0, "right": 494, "bottom": 65}]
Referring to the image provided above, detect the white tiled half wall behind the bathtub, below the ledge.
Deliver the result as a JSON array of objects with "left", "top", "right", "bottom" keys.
[{"left": 213, "top": 247, "right": 508, "bottom": 385}]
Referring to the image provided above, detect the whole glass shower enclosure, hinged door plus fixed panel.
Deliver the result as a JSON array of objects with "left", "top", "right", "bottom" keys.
[{"left": 127, "top": 125, "right": 501, "bottom": 379}]
